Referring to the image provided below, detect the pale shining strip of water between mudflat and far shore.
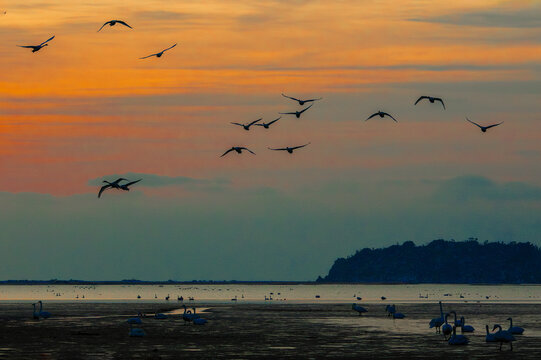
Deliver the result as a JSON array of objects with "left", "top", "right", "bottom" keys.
[{"left": 0, "top": 284, "right": 541, "bottom": 305}]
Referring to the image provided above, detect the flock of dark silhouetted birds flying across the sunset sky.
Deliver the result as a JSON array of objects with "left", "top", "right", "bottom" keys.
[{"left": 17, "top": 20, "right": 503, "bottom": 198}]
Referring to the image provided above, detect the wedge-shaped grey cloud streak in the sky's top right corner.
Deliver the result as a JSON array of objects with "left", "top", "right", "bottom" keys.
[{"left": 409, "top": 5, "right": 541, "bottom": 28}]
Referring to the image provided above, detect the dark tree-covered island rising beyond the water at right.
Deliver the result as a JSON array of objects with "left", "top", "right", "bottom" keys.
[{"left": 316, "top": 238, "right": 541, "bottom": 284}]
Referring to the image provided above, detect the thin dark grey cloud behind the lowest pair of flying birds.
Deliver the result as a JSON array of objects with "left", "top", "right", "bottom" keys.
[{"left": 88, "top": 172, "right": 230, "bottom": 187}]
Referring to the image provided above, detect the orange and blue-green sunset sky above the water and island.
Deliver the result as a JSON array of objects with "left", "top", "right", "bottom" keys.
[{"left": 0, "top": 0, "right": 541, "bottom": 280}]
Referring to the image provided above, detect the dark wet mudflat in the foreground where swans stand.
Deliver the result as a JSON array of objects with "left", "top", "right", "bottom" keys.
[{"left": 0, "top": 302, "right": 541, "bottom": 359}]
